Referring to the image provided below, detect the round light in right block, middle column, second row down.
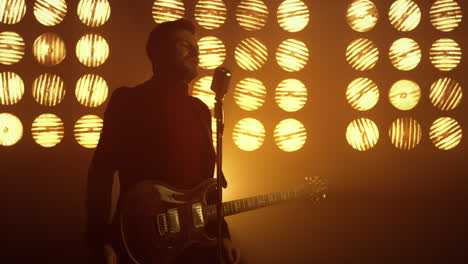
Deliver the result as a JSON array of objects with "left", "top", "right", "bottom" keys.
[{"left": 389, "top": 38, "right": 421, "bottom": 71}]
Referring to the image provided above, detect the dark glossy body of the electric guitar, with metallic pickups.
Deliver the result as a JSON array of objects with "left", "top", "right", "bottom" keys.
[{"left": 119, "top": 179, "right": 216, "bottom": 264}]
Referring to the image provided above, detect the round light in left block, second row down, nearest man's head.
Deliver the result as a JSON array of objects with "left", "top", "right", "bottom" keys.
[{"left": 76, "top": 34, "right": 109, "bottom": 67}]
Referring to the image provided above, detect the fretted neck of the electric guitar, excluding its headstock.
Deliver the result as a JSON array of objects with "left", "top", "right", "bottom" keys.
[{"left": 206, "top": 189, "right": 305, "bottom": 219}]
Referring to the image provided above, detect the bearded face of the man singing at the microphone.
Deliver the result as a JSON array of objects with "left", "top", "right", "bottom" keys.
[{"left": 169, "top": 30, "right": 198, "bottom": 82}]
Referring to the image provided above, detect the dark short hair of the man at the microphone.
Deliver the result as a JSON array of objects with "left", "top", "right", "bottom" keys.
[{"left": 146, "top": 18, "right": 195, "bottom": 64}]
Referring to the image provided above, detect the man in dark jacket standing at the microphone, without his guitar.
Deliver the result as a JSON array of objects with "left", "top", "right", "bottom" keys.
[{"left": 85, "top": 19, "right": 240, "bottom": 264}]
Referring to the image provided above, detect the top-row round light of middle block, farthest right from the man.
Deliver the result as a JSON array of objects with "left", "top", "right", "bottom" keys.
[{"left": 276, "top": 0, "right": 309, "bottom": 32}]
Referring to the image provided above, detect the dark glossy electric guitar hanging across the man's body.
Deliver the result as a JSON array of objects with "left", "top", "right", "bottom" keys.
[{"left": 119, "top": 177, "right": 325, "bottom": 264}]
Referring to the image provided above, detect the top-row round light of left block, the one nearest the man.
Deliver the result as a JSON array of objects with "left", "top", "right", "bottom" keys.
[{"left": 78, "top": 0, "right": 111, "bottom": 27}]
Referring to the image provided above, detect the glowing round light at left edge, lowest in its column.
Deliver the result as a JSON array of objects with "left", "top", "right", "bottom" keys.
[{"left": 0, "top": 113, "right": 23, "bottom": 147}]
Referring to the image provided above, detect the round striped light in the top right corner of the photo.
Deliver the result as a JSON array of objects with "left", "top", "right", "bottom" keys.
[{"left": 429, "top": 0, "right": 462, "bottom": 32}]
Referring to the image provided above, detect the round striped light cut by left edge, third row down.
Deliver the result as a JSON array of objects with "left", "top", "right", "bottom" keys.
[{"left": 0, "top": 72, "right": 24, "bottom": 105}]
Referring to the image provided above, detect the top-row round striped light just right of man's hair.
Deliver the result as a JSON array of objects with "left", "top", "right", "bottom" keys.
[{"left": 195, "top": 0, "right": 227, "bottom": 29}]
